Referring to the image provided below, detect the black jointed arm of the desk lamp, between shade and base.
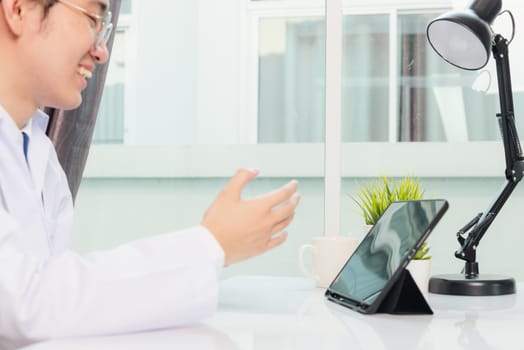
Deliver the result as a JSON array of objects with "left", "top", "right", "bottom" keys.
[{"left": 455, "top": 34, "right": 524, "bottom": 267}]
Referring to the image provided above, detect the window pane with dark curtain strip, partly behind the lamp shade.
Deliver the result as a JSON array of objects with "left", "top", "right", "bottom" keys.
[{"left": 398, "top": 13, "right": 500, "bottom": 142}]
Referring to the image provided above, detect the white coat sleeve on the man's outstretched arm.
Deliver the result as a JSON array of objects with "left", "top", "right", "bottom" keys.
[{"left": 0, "top": 210, "right": 224, "bottom": 344}]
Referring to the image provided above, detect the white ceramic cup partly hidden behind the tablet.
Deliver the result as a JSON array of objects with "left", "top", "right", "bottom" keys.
[{"left": 298, "top": 236, "right": 358, "bottom": 288}]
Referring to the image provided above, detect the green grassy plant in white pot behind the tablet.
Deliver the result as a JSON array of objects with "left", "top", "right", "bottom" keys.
[{"left": 352, "top": 176, "right": 431, "bottom": 295}]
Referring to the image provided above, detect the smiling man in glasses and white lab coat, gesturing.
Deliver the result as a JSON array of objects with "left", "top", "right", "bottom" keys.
[{"left": 0, "top": 0, "right": 300, "bottom": 347}]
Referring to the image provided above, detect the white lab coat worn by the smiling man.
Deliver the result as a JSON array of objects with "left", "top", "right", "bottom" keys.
[{"left": 0, "top": 106, "right": 224, "bottom": 349}]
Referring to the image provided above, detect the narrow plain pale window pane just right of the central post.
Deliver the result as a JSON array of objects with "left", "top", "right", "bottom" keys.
[{"left": 342, "top": 14, "right": 390, "bottom": 142}]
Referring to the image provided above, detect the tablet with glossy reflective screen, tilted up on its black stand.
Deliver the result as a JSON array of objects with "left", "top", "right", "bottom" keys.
[{"left": 325, "top": 199, "right": 448, "bottom": 313}]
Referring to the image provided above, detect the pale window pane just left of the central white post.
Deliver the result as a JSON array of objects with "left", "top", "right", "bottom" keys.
[{"left": 258, "top": 18, "right": 326, "bottom": 143}]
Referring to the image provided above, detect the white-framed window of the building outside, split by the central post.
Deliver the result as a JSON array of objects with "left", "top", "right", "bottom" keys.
[{"left": 256, "top": 1, "right": 524, "bottom": 143}]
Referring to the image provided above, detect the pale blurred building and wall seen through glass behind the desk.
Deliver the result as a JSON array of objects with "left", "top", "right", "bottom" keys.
[{"left": 73, "top": 0, "right": 524, "bottom": 280}]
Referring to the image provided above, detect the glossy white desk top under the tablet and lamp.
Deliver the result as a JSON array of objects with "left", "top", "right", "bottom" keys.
[{"left": 20, "top": 277, "right": 524, "bottom": 350}]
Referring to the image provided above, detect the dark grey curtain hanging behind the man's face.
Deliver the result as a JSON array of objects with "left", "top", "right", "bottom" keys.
[{"left": 44, "top": 0, "right": 121, "bottom": 200}]
